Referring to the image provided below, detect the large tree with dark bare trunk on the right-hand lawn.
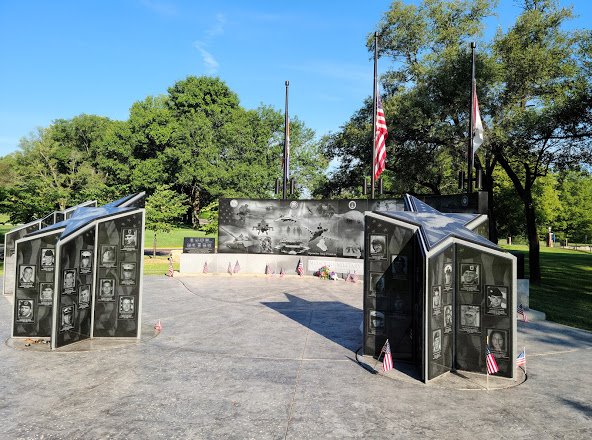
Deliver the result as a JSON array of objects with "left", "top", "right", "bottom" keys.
[{"left": 489, "top": 0, "right": 592, "bottom": 282}]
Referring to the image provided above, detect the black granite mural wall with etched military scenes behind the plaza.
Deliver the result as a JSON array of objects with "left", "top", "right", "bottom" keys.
[{"left": 218, "top": 199, "right": 403, "bottom": 258}]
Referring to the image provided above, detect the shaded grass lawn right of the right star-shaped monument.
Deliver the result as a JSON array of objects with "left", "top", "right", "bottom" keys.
[{"left": 503, "top": 245, "right": 592, "bottom": 331}]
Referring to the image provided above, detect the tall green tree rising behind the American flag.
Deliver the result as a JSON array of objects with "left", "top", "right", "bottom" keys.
[{"left": 316, "top": 0, "right": 495, "bottom": 199}]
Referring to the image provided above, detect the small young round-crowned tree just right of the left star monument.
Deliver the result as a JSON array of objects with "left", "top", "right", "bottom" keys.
[{"left": 146, "top": 185, "right": 187, "bottom": 257}]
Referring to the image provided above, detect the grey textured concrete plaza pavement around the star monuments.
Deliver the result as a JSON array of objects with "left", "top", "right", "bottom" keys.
[{"left": 0, "top": 274, "right": 592, "bottom": 439}]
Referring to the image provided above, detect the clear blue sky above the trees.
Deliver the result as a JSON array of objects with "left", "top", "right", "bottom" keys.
[{"left": 0, "top": 0, "right": 592, "bottom": 156}]
